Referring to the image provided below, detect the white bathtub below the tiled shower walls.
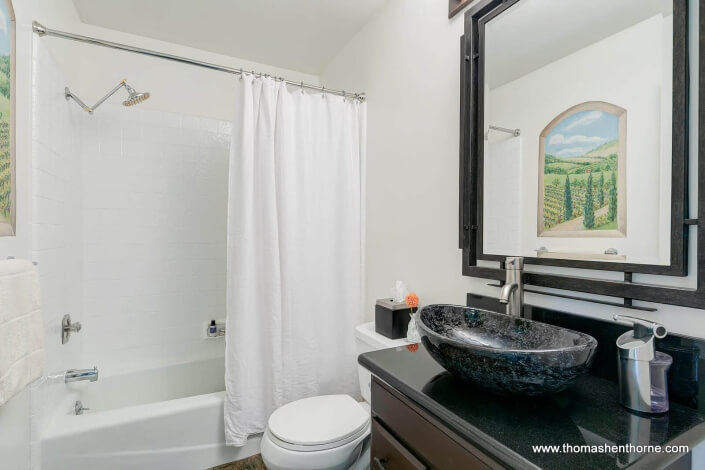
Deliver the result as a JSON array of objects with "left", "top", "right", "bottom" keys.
[{"left": 41, "top": 359, "right": 260, "bottom": 470}]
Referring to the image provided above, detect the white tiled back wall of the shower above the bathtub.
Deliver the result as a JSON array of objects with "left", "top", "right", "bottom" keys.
[{"left": 80, "top": 104, "right": 232, "bottom": 375}]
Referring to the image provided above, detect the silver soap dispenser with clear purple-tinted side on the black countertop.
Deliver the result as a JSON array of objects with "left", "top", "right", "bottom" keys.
[{"left": 614, "top": 315, "right": 673, "bottom": 413}]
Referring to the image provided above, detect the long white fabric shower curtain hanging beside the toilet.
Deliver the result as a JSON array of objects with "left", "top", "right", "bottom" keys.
[{"left": 225, "top": 75, "right": 365, "bottom": 446}]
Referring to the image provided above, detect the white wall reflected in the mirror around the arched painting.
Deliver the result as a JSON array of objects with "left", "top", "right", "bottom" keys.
[{"left": 483, "top": 15, "right": 673, "bottom": 264}]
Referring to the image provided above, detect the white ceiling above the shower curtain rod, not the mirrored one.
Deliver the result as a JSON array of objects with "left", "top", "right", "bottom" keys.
[{"left": 73, "top": 0, "right": 387, "bottom": 74}]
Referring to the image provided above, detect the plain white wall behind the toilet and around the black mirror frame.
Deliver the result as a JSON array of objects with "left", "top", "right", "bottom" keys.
[{"left": 321, "top": 0, "right": 705, "bottom": 337}]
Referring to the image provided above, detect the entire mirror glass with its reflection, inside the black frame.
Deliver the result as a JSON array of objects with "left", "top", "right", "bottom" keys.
[{"left": 482, "top": 0, "right": 673, "bottom": 265}]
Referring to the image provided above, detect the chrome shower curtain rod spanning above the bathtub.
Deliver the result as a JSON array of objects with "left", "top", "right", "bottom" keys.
[{"left": 32, "top": 21, "right": 366, "bottom": 101}]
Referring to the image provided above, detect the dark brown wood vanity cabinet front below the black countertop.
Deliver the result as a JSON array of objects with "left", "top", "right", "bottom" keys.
[{"left": 370, "top": 377, "right": 502, "bottom": 470}]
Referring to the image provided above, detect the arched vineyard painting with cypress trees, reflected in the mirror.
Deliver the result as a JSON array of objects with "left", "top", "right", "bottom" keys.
[{"left": 537, "top": 101, "right": 627, "bottom": 238}]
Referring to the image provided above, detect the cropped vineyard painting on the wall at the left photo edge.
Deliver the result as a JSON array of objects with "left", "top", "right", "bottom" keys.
[{"left": 0, "top": 0, "right": 16, "bottom": 236}]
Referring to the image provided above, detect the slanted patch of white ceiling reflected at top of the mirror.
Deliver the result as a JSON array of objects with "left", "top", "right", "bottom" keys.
[{"left": 485, "top": 0, "right": 673, "bottom": 89}]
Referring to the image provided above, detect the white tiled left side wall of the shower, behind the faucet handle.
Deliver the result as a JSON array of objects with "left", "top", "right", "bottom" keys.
[{"left": 30, "top": 42, "right": 85, "bottom": 452}]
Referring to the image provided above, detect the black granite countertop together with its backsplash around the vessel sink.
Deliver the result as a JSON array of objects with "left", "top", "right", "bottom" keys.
[{"left": 359, "top": 299, "right": 705, "bottom": 469}]
